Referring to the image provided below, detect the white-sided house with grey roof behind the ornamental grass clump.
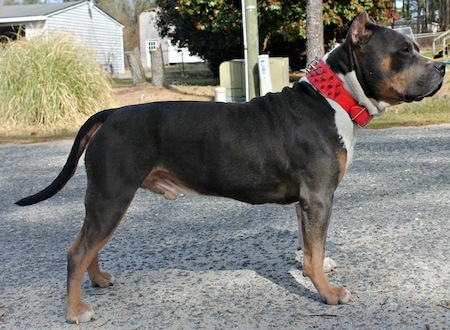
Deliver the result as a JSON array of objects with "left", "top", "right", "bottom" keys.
[{"left": 0, "top": 1, "right": 124, "bottom": 74}]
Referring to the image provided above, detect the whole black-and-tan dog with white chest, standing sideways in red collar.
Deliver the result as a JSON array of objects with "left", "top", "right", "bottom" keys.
[{"left": 17, "top": 12, "right": 445, "bottom": 323}]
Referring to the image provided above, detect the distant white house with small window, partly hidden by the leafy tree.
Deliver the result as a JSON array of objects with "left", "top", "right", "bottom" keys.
[{"left": 139, "top": 10, "right": 203, "bottom": 68}]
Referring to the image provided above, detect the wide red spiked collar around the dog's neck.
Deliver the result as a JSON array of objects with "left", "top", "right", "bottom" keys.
[{"left": 306, "top": 60, "right": 373, "bottom": 127}]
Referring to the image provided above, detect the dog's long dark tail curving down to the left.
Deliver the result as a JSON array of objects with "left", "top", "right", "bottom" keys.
[{"left": 16, "top": 110, "right": 113, "bottom": 206}]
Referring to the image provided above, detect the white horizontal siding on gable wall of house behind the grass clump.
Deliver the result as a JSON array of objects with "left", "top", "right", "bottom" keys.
[{"left": 46, "top": 2, "right": 125, "bottom": 74}]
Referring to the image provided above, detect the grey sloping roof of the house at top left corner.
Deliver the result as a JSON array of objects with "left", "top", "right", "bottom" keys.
[{"left": 0, "top": 1, "right": 84, "bottom": 19}]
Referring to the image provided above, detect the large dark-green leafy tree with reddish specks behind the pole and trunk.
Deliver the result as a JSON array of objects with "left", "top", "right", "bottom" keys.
[{"left": 156, "top": 0, "right": 393, "bottom": 74}]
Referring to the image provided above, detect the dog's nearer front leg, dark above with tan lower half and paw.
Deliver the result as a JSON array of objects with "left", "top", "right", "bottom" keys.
[{"left": 296, "top": 190, "right": 352, "bottom": 305}]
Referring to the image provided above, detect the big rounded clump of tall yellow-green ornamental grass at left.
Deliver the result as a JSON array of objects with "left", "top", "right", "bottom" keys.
[{"left": 0, "top": 34, "right": 112, "bottom": 129}]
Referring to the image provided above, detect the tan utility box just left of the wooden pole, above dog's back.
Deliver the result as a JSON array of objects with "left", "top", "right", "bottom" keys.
[{"left": 219, "top": 59, "right": 245, "bottom": 102}]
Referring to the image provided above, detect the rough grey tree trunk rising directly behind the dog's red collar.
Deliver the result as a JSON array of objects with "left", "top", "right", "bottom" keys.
[{"left": 306, "top": 0, "right": 324, "bottom": 63}]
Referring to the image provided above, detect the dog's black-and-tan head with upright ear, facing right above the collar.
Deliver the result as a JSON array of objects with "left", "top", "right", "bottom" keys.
[{"left": 336, "top": 12, "right": 445, "bottom": 115}]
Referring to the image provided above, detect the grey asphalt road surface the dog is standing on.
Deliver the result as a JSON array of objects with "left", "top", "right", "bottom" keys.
[{"left": 0, "top": 126, "right": 450, "bottom": 329}]
